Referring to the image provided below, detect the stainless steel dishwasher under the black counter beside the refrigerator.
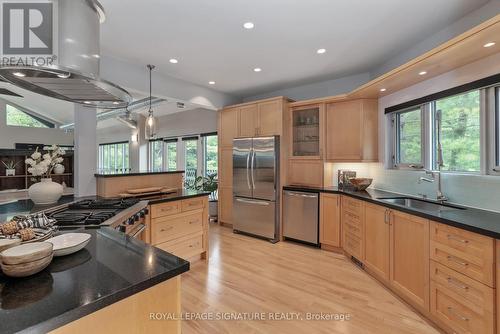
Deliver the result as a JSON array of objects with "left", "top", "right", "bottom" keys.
[{"left": 283, "top": 190, "right": 319, "bottom": 246}]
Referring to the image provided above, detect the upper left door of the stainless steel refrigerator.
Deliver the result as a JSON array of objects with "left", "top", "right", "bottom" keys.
[{"left": 233, "top": 138, "right": 252, "bottom": 197}]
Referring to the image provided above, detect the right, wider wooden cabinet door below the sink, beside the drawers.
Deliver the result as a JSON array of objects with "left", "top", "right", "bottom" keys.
[{"left": 390, "top": 210, "right": 430, "bottom": 313}]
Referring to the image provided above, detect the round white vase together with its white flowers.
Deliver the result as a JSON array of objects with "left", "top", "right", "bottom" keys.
[{"left": 25, "top": 145, "right": 65, "bottom": 205}]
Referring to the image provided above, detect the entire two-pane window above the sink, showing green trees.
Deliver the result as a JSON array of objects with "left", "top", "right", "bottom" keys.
[{"left": 392, "top": 90, "right": 482, "bottom": 173}]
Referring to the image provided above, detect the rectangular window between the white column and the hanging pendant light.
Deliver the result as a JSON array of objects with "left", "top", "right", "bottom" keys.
[{"left": 98, "top": 142, "right": 130, "bottom": 173}]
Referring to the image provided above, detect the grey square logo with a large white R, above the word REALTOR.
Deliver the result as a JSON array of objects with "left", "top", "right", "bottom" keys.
[{"left": 2, "top": 2, "right": 54, "bottom": 55}]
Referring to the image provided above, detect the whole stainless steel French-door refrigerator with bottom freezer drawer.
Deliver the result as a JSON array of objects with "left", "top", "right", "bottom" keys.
[{"left": 233, "top": 136, "right": 280, "bottom": 242}]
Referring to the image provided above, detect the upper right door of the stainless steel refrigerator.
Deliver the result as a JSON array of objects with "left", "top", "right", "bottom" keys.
[{"left": 250, "top": 137, "right": 279, "bottom": 201}]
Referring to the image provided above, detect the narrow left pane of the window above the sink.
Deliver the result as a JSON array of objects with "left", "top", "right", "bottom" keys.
[{"left": 394, "top": 107, "right": 424, "bottom": 166}]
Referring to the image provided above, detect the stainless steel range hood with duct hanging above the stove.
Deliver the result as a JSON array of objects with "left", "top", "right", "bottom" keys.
[{"left": 0, "top": 0, "right": 132, "bottom": 109}]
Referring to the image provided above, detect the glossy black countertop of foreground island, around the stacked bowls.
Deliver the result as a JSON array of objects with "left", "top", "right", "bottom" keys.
[{"left": 0, "top": 228, "right": 189, "bottom": 334}]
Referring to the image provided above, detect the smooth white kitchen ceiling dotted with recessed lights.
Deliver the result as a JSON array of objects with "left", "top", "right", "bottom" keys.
[{"left": 101, "top": 0, "right": 488, "bottom": 96}]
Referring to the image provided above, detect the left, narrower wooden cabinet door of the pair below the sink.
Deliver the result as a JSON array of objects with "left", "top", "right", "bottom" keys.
[{"left": 364, "top": 203, "right": 390, "bottom": 282}]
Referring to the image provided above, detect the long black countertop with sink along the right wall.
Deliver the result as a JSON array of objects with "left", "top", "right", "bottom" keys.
[{"left": 283, "top": 185, "right": 500, "bottom": 239}]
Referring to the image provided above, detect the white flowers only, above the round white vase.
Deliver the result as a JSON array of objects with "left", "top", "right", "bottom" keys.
[{"left": 25, "top": 145, "right": 66, "bottom": 178}]
